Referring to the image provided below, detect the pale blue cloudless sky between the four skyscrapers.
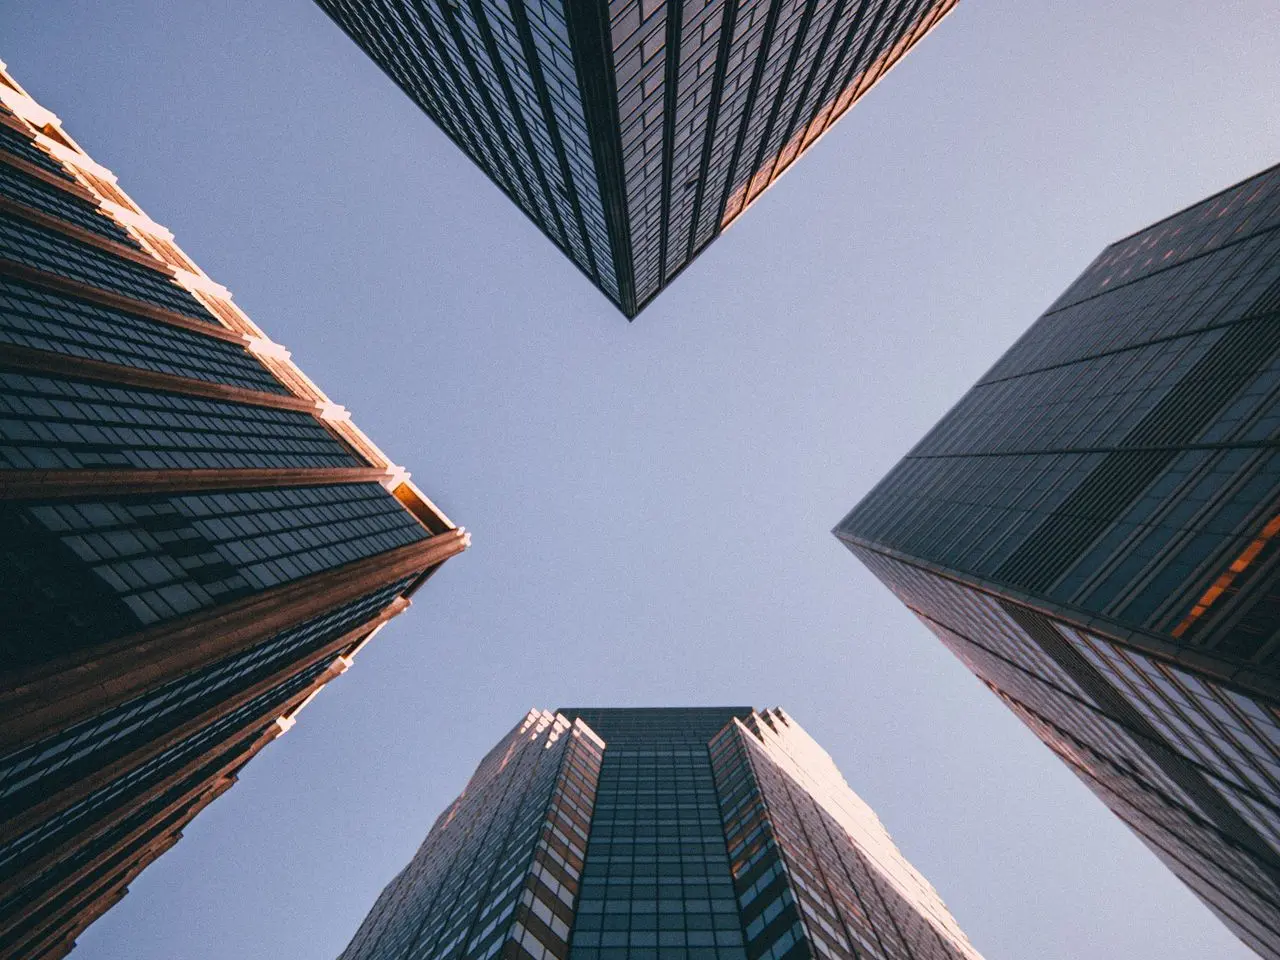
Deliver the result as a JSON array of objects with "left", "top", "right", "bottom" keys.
[{"left": 0, "top": 0, "right": 1280, "bottom": 960}]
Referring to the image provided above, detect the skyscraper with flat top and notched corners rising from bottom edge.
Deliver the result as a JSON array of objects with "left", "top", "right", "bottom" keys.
[{"left": 340, "top": 707, "right": 980, "bottom": 960}]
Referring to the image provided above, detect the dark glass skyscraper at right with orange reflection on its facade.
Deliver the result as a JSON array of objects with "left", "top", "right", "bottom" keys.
[{"left": 835, "top": 166, "right": 1280, "bottom": 957}]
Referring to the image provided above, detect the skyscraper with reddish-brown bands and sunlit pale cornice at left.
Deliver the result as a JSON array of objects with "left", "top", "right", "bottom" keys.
[{"left": 0, "top": 64, "right": 467, "bottom": 960}]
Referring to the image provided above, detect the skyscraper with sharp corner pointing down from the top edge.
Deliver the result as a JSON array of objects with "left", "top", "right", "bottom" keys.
[{"left": 317, "top": 0, "right": 956, "bottom": 317}]
